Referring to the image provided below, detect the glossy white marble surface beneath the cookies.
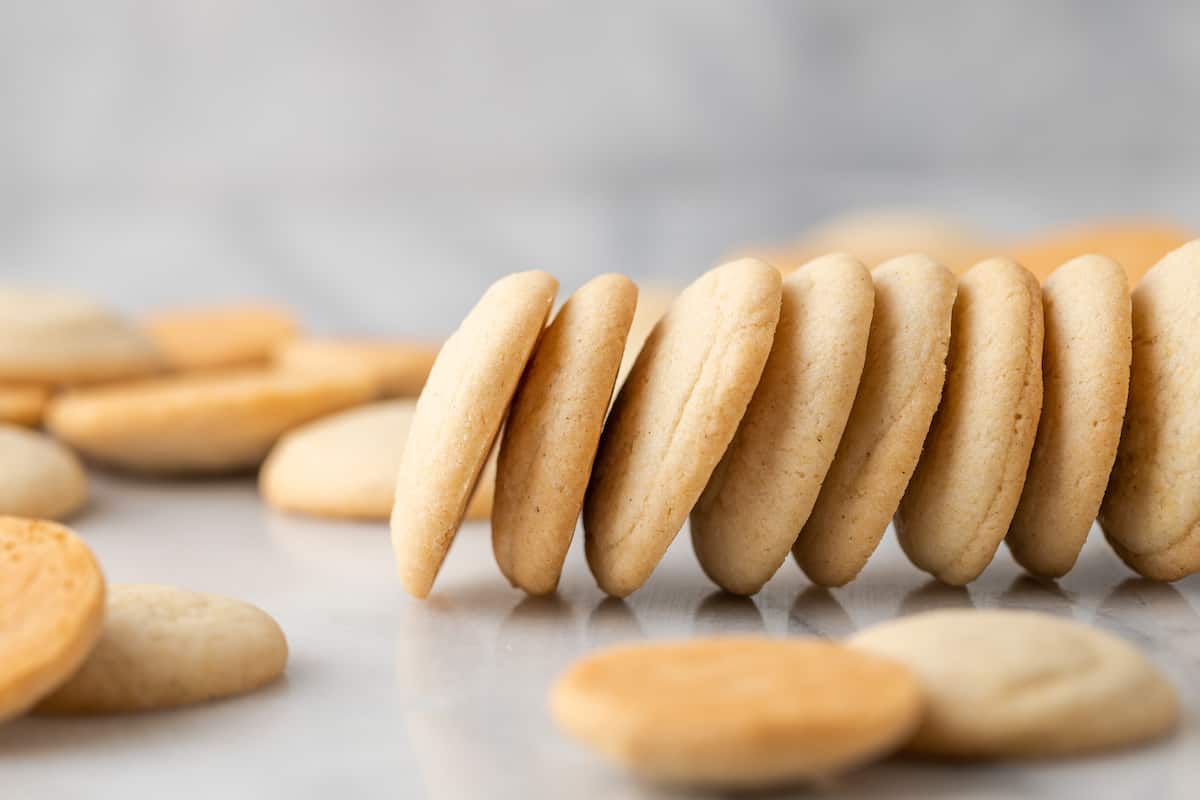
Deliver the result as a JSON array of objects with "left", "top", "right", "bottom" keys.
[{"left": 0, "top": 476, "right": 1200, "bottom": 800}]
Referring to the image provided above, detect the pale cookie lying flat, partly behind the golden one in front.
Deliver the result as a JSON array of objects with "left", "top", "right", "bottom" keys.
[{"left": 850, "top": 609, "right": 1178, "bottom": 758}]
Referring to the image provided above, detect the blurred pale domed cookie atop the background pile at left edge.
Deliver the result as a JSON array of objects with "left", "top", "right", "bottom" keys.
[{"left": 0, "top": 289, "right": 163, "bottom": 384}]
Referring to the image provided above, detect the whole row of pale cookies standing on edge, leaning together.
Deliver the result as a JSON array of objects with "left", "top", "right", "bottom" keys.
[{"left": 391, "top": 241, "right": 1200, "bottom": 596}]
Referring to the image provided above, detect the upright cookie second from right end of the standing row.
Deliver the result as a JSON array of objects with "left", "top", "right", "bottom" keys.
[{"left": 1006, "top": 255, "right": 1132, "bottom": 578}]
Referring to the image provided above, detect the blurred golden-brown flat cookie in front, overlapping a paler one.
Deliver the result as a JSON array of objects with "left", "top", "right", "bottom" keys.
[{"left": 551, "top": 637, "right": 923, "bottom": 789}]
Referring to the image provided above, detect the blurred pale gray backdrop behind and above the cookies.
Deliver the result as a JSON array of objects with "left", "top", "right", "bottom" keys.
[{"left": 0, "top": 0, "right": 1200, "bottom": 335}]
